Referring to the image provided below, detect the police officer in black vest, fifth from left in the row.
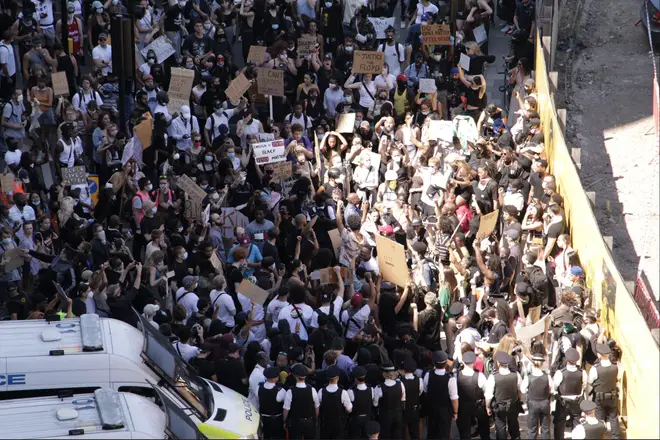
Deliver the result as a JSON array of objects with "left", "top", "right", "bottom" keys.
[{"left": 374, "top": 362, "right": 406, "bottom": 439}]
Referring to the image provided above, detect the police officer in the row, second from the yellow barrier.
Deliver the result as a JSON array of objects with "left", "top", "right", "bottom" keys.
[{"left": 552, "top": 348, "right": 587, "bottom": 440}]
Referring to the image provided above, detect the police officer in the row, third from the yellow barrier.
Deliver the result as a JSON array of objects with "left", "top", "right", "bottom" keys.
[{"left": 520, "top": 354, "right": 552, "bottom": 440}]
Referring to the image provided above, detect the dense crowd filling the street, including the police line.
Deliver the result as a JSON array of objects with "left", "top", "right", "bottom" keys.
[{"left": 0, "top": 0, "right": 622, "bottom": 440}]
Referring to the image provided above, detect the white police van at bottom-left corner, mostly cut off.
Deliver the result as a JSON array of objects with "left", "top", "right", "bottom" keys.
[{"left": 0, "top": 388, "right": 206, "bottom": 439}]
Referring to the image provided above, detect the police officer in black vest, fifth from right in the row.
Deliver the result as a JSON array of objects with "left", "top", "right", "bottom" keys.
[{"left": 456, "top": 351, "right": 490, "bottom": 440}]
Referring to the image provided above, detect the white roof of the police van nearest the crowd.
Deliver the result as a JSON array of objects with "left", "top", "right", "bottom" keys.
[{"left": 0, "top": 315, "right": 140, "bottom": 361}]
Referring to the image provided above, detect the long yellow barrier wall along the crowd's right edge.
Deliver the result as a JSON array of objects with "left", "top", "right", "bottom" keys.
[{"left": 535, "top": 33, "right": 660, "bottom": 439}]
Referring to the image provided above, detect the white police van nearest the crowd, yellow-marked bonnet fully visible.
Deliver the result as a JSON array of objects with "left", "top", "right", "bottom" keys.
[{"left": 0, "top": 315, "right": 260, "bottom": 439}]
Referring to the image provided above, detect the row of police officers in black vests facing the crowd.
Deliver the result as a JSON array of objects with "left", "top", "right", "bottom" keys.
[{"left": 259, "top": 344, "right": 619, "bottom": 440}]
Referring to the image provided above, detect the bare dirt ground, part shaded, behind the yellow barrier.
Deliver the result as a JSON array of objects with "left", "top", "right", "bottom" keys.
[{"left": 555, "top": 0, "right": 660, "bottom": 298}]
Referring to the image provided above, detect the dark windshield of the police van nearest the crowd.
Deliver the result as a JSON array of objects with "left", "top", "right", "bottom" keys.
[{"left": 142, "top": 321, "right": 213, "bottom": 421}]
